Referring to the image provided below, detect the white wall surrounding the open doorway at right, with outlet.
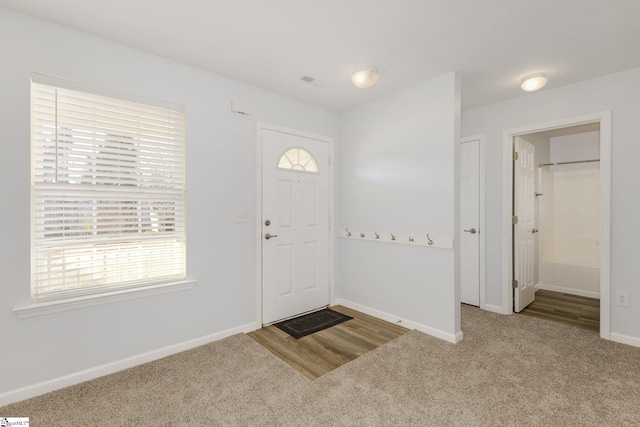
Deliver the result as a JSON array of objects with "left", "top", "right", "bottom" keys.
[{"left": 462, "top": 68, "right": 640, "bottom": 345}]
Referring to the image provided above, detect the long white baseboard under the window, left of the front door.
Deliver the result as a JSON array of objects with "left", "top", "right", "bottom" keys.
[{"left": 0, "top": 322, "right": 258, "bottom": 406}]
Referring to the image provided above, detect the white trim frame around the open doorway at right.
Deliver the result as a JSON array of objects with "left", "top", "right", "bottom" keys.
[{"left": 501, "top": 111, "right": 611, "bottom": 339}]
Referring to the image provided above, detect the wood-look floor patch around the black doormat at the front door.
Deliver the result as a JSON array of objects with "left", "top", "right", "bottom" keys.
[{"left": 247, "top": 306, "right": 409, "bottom": 380}]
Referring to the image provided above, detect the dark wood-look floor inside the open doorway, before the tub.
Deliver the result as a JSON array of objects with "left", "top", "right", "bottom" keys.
[{"left": 520, "top": 289, "right": 600, "bottom": 332}]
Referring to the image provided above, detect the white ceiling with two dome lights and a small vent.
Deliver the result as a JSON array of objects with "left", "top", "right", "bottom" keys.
[{"left": 0, "top": 0, "right": 640, "bottom": 111}]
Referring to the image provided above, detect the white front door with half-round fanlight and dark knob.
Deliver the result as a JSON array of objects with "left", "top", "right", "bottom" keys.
[{"left": 261, "top": 129, "right": 329, "bottom": 324}]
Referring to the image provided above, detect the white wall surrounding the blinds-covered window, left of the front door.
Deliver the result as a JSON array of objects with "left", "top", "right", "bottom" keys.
[{"left": 0, "top": 8, "right": 339, "bottom": 406}]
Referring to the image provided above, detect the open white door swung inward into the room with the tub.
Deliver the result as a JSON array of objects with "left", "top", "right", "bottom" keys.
[{"left": 513, "top": 137, "right": 536, "bottom": 313}]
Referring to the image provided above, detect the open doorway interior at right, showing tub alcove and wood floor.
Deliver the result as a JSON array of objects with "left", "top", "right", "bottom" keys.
[{"left": 513, "top": 122, "right": 600, "bottom": 330}]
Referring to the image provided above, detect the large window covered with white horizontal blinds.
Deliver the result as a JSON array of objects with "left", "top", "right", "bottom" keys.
[{"left": 31, "top": 74, "right": 186, "bottom": 302}]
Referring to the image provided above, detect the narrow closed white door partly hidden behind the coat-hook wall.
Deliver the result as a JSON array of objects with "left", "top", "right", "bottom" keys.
[{"left": 460, "top": 140, "right": 480, "bottom": 306}]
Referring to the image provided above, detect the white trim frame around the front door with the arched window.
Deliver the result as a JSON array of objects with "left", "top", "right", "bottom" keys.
[{"left": 255, "top": 121, "right": 335, "bottom": 327}]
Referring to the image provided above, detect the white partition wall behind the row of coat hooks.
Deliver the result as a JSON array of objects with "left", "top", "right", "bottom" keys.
[{"left": 336, "top": 73, "right": 460, "bottom": 339}]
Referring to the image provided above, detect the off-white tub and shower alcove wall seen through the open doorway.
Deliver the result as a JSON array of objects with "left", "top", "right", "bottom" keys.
[{"left": 539, "top": 131, "right": 600, "bottom": 297}]
